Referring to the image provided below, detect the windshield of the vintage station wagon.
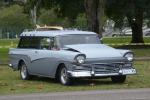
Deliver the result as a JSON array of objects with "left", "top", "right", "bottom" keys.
[{"left": 59, "top": 34, "right": 100, "bottom": 48}]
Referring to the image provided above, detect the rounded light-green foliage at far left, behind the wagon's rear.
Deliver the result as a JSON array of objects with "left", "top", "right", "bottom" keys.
[{"left": 0, "top": 5, "right": 31, "bottom": 36}]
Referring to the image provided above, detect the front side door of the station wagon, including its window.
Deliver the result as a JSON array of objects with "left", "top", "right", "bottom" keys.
[{"left": 30, "top": 37, "right": 55, "bottom": 76}]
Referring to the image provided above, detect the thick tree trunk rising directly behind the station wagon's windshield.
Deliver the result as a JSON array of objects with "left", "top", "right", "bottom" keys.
[{"left": 84, "top": 0, "right": 105, "bottom": 36}]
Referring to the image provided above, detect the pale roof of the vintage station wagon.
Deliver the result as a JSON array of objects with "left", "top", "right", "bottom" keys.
[{"left": 20, "top": 30, "right": 96, "bottom": 37}]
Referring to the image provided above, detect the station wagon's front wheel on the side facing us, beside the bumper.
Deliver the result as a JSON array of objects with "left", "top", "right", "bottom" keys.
[{"left": 59, "top": 66, "right": 71, "bottom": 85}]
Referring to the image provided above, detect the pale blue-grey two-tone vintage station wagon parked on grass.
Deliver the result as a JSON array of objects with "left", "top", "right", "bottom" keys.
[{"left": 9, "top": 30, "right": 136, "bottom": 85}]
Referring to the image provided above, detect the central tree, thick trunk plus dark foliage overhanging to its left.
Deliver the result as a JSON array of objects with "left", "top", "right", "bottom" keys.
[{"left": 26, "top": 0, "right": 105, "bottom": 35}]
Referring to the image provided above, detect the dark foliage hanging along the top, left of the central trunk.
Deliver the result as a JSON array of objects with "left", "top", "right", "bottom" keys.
[{"left": 25, "top": 0, "right": 85, "bottom": 25}]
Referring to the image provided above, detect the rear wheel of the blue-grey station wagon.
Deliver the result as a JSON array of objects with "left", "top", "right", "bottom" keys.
[{"left": 20, "top": 62, "right": 30, "bottom": 80}]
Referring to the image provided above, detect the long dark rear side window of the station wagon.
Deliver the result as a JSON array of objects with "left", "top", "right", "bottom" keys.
[{"left": 18, "top": 37, "right": 41, "bottom": 49}]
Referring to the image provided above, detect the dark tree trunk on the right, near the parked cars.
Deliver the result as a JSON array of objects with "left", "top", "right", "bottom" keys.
[{"left": 127, "top": 9, "right": 144, "bottom": 43}]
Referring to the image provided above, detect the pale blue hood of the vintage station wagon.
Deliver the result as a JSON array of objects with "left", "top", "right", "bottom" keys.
[{"left": 65, "top": 44, "right": 122, "bottom": 58}]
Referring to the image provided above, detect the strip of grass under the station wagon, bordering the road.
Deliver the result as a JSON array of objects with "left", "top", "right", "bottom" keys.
[{"left": 0, "top": 61, "right": 150, "bottom": 95}]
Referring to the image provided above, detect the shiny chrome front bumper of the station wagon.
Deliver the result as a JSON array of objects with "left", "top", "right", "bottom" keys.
[{"left": 68, "top": 68, "right": 136, "bottom": 78}]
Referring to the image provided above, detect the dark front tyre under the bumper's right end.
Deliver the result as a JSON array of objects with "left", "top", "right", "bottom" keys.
[{"left": 111, "top": 75, "right": 126, "bottom": 83}]
